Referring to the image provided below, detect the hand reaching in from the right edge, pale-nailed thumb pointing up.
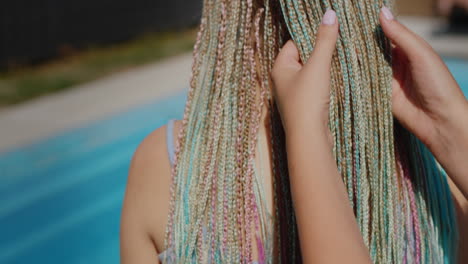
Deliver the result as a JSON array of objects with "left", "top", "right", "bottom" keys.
[{"left": 380, "top": 7, "right": 468, "bottom": 198}]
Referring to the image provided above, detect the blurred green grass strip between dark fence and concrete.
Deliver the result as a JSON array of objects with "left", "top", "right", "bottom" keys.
[{"left": 0, "top": 29, "right": 196, "bottom": 108}]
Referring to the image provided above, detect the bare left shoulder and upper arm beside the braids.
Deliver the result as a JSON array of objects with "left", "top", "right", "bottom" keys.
[{"left": 122, "top": 121, "right": 180, "bottom": 252}]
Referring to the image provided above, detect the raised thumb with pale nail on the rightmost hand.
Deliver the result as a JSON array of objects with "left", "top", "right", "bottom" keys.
[{"left": 380, "top": 6, "right": 434, "bottom": 59}]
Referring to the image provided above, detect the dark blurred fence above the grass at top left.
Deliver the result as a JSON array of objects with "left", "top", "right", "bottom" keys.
[{"left": 0, "top": 0, "right": 202, "bottom": 68}]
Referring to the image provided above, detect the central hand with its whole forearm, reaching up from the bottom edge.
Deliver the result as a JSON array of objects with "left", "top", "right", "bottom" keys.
[{"left": 272, "top": 10, "right": 371, "bottom": 263}]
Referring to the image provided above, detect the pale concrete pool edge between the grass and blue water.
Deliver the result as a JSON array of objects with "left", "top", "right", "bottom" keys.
[{"left": 0, "top": 17, "right": 468, "bottom": 153}]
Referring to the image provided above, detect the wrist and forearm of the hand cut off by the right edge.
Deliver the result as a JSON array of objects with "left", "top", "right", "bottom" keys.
[{"left": 431, "top": 100, "right": 468, "bottom": 199}]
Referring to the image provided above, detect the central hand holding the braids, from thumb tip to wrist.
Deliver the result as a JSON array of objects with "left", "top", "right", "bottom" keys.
[{"left": 272, "top": 10, "right": 338, "bottom": 142}]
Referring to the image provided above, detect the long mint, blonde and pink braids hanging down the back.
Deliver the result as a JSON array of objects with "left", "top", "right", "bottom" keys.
[{"left": 163, "top": 0, "right": 458, "bottom": 263}]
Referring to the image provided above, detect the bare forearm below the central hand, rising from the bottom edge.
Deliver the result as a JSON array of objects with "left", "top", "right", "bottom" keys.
[{"left": 286, "top": 127, "right": 371, "bottom": 263}]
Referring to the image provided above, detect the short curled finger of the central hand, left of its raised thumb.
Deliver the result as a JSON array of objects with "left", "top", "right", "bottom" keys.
[{"left": 271, "top": 40, "right": 302, "bottom": 87}]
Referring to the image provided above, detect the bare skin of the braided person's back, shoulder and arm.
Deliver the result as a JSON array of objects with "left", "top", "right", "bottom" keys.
[{"left": 121, "top": 118, "right": 273, "bottom": 263}]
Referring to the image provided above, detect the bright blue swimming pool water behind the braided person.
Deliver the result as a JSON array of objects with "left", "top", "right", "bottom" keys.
[{"left": 0, "top": 60, "right": 468, "bottom": 264}]
